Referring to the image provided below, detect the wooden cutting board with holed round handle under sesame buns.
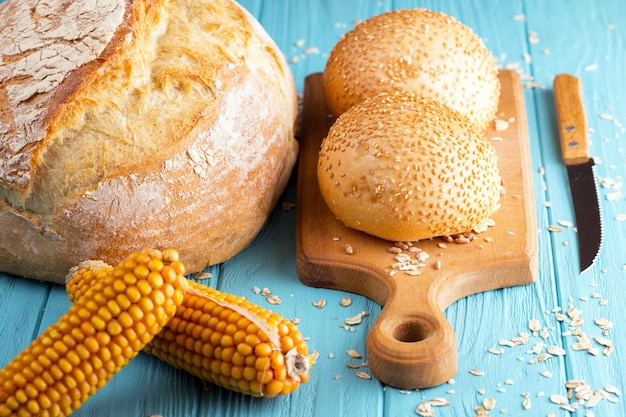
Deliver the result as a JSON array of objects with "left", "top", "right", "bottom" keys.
[{"left": 296, "top": 70, "right": 537, "bottom": 388}]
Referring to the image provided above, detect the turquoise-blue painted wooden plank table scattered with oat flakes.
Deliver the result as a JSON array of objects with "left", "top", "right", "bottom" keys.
[{"left": 0, "top": 0, "right": 626, "bottom": 417}]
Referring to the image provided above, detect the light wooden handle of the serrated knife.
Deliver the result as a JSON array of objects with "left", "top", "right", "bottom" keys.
[{"left": 553, "top": 74, "right": 589, "bottom": 165}]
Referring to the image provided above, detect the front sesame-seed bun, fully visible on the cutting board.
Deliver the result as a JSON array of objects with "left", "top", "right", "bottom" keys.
[{"left": 317, "top": 93, "right": 501, "bottom": 241}]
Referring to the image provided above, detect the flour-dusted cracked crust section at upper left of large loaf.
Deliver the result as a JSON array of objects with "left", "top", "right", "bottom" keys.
[{"left": 0, "top": 0, "right": 125, "bottom": 189}]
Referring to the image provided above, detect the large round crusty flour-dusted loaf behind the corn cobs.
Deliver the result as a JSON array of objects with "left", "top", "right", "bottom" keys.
[{"left": 0, "top": 0, "right": 298, "bottom": 282}]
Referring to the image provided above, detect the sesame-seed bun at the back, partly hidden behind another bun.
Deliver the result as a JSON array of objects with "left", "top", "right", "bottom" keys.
[{"left": 324, "top": 9, "right": 500, "bottom": 128}]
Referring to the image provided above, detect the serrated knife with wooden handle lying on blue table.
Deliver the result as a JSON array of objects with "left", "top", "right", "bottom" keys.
[{"left": 553, "top": 74, "right": 603, "bottom": 274}]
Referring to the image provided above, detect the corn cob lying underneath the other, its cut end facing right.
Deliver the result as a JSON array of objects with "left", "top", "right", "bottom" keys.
[{"left": 68, "top": 260, "right": 313, "bottom": 397}]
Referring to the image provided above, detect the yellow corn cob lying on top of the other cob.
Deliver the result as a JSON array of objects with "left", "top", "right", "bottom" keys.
[{"left": 0, "top": 250, "right": 187, "bottom": 417}]
